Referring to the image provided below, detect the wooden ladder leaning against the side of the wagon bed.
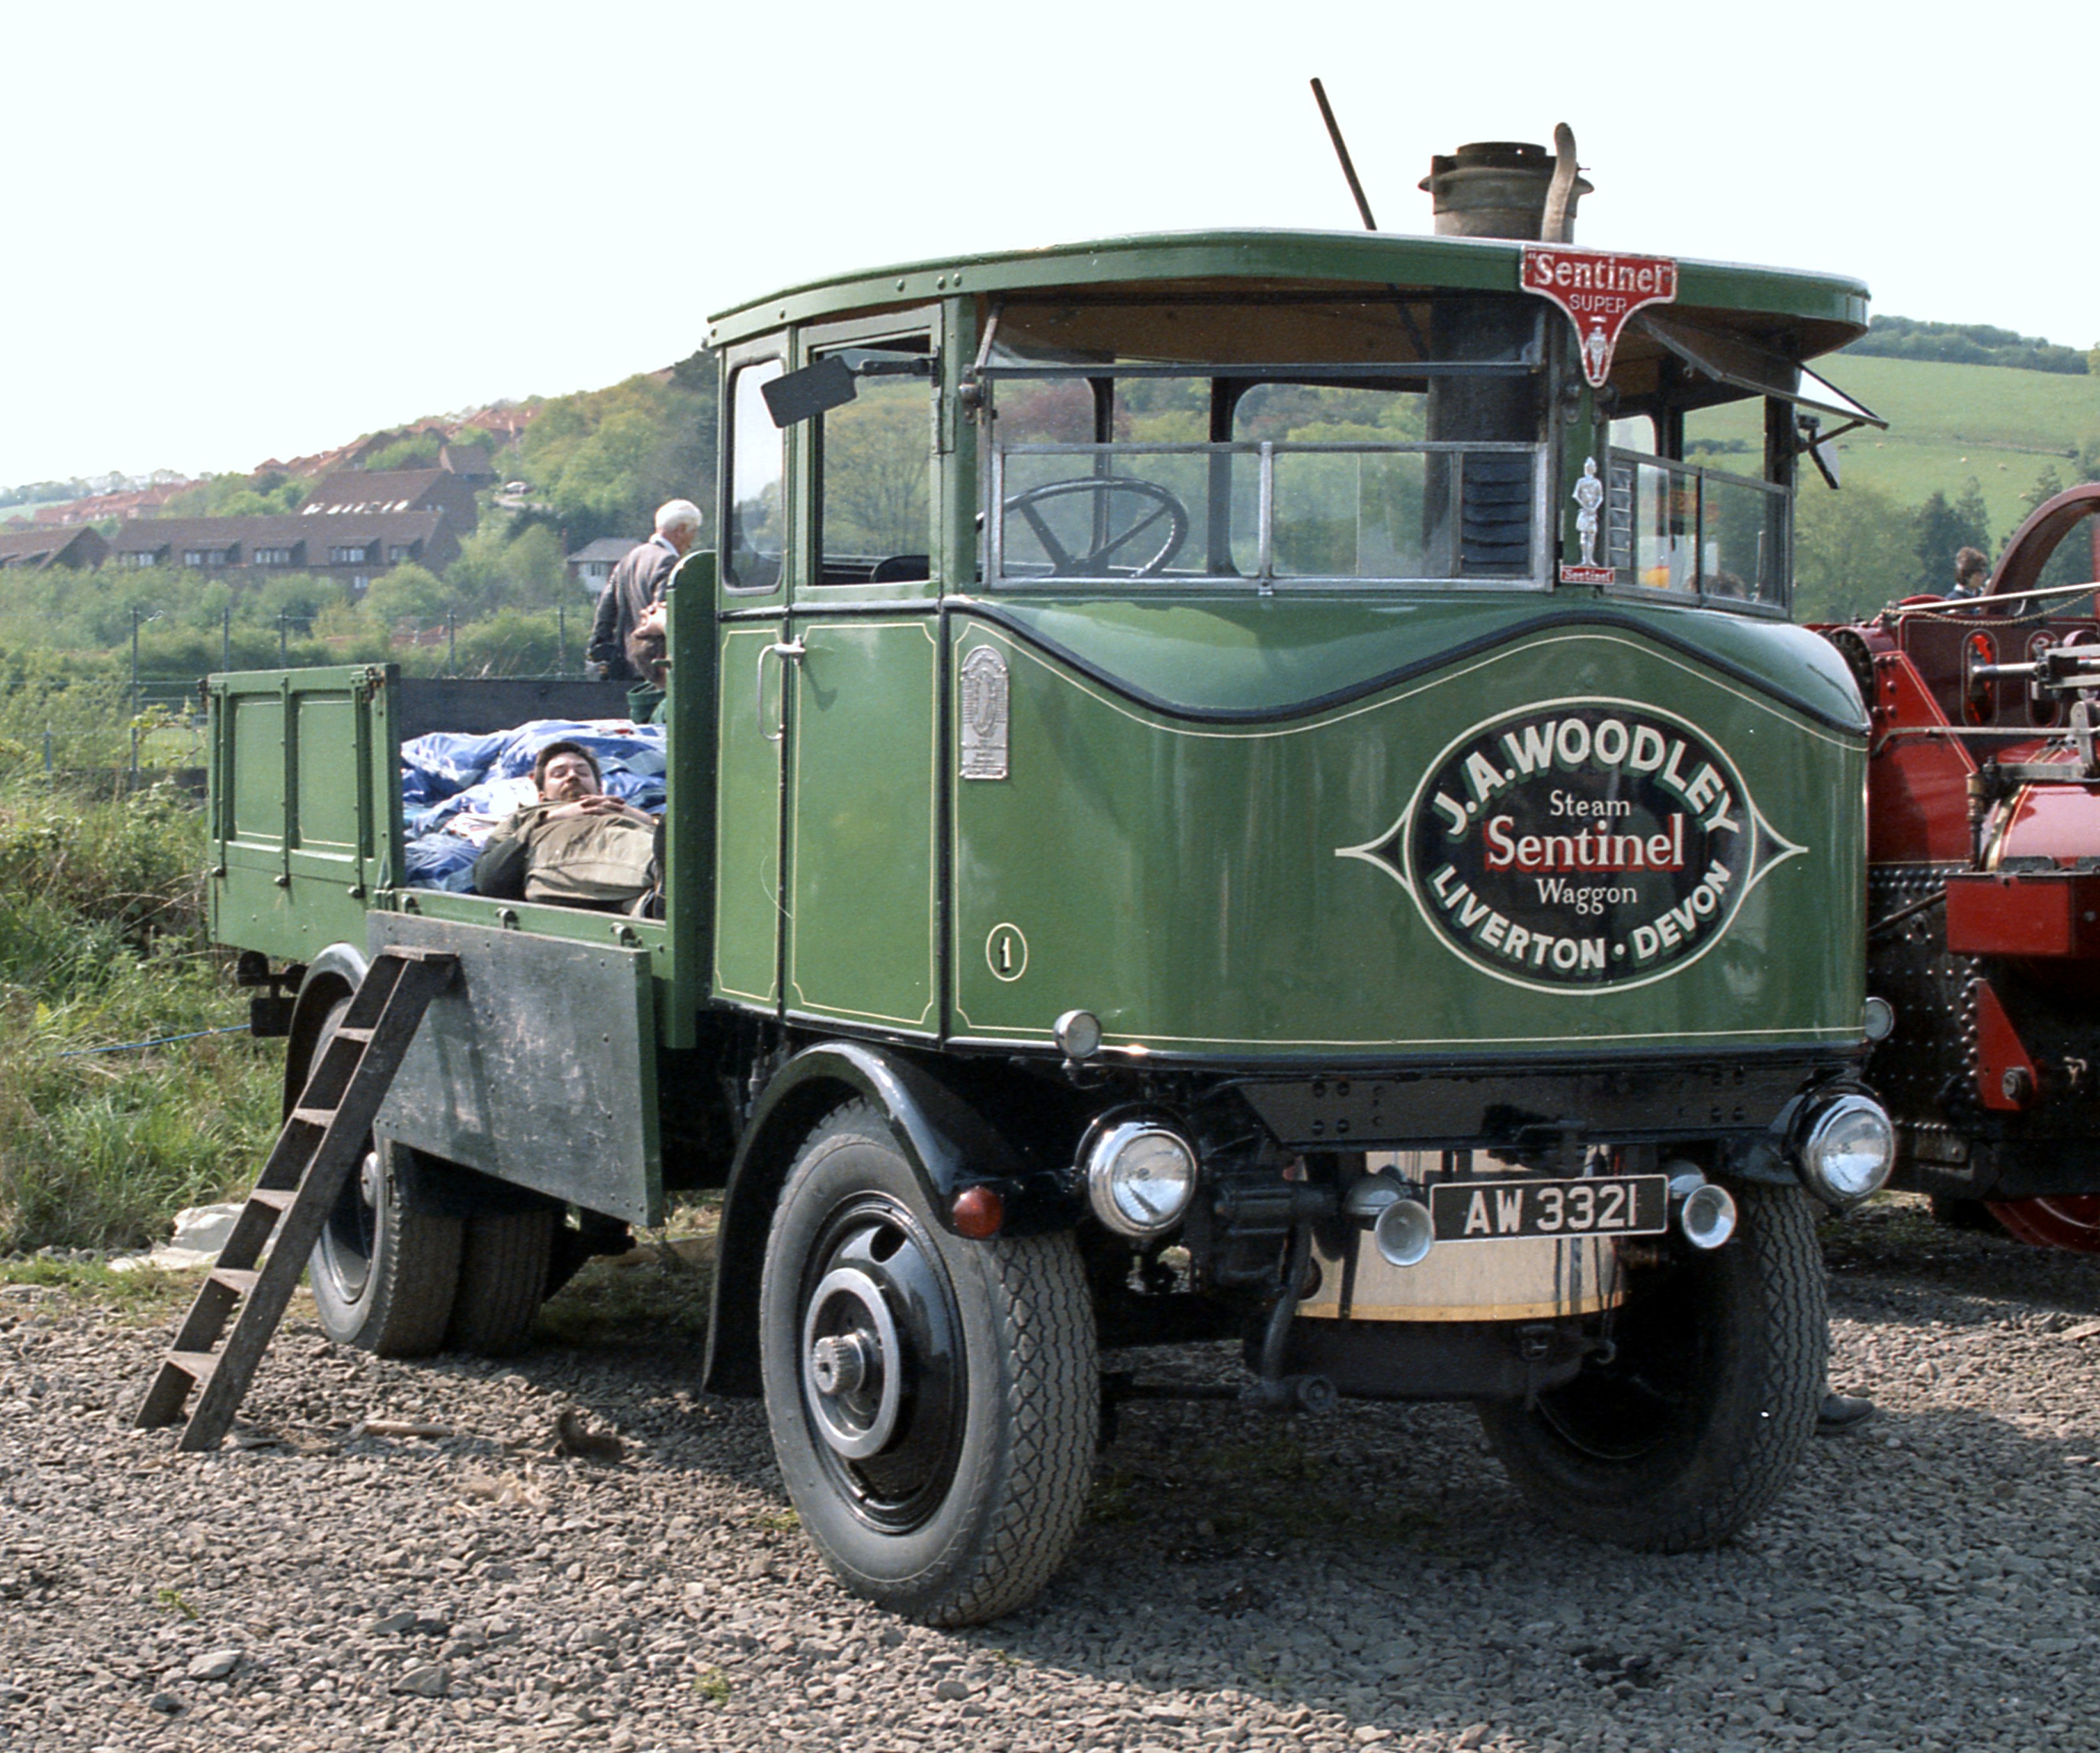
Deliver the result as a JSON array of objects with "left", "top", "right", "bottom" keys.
[{"left": 132, "top": 945, "right": 460, "bottom": 1451}]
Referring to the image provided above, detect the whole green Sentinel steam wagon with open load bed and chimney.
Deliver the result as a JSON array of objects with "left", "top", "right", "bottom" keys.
[{"left": 170, "top": 130, "right": 1892, "bottom": 1623}]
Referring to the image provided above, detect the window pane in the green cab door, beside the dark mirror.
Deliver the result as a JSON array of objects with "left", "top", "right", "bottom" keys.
[{"left": 817, "top": 342, "right": 935, "bottom": 583}]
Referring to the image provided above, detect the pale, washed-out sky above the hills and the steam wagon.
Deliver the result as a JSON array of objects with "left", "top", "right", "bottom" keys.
[{"left": 0, "top": 0, "right": 2100, "bottom": 483}]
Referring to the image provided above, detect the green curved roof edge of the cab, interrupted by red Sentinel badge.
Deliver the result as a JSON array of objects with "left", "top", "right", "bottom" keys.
[{"left": 708, "top": 231, "right": 1867, "bottom": 359}]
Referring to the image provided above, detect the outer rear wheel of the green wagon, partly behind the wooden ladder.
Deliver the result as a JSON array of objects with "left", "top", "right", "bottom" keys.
[{"left": 306, "top": 995, "right": 460, "bottom": 1358}]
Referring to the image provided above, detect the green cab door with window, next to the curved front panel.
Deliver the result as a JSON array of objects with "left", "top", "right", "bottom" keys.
[{"left": 779, "top": 311, "right": 941, "bottom": 1035}]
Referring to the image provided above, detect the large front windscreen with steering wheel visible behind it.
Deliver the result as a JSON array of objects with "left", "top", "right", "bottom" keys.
[{"left": 985, "top": 296, "right": 1547, "bottom": 590}]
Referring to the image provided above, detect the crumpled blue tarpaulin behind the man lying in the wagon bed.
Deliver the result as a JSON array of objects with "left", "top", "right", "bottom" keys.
[{"left": 401, "top": 718, "right": 663, "bottom": 893}]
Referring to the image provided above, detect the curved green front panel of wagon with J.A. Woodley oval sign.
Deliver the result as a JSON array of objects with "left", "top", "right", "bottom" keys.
[{"left": 952, "top": 600, "right": 1865, "bottom": 1063}]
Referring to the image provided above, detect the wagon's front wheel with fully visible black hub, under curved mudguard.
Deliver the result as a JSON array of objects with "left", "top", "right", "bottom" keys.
[{"left": 758, "top": 1102, "right": 1101, "bottom": 1625}]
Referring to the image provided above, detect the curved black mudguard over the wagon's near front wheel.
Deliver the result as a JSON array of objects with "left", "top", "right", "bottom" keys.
[{"left": 702, "top": 1041, "right": 1079, "bottom": 1394}]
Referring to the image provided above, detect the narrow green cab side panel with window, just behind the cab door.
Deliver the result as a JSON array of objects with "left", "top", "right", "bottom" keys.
[{"left": 712, "top": 351, "right": 792, "bottom": 1010}]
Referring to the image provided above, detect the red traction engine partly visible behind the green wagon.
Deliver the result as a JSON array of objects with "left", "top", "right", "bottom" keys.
[{"left": 1823, "top": 485, "right": 2100, "bottom": 1253}]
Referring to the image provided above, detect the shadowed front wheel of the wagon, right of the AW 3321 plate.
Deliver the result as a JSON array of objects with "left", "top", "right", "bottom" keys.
[{"left": 1481, "top": 1186, "right": 1829, "bottom": 1552}]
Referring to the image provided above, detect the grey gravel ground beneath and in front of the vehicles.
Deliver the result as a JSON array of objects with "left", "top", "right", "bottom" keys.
[{"left": 0, "top": 1203, "right": 2100, "bottom": 1753}]
